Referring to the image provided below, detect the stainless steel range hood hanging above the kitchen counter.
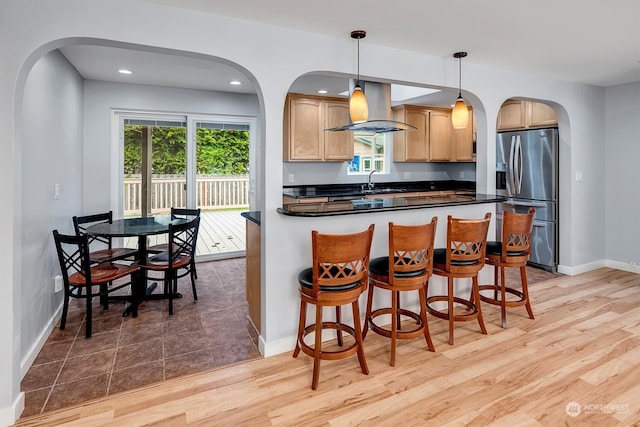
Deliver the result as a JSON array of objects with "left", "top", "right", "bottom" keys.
[{"left": 326, "top": 80, "right": 415, "bottom": 133}]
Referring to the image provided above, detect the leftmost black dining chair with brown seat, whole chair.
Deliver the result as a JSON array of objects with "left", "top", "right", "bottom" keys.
[{"left": 53, "top": 230, "right": 139, "bottom": 338}]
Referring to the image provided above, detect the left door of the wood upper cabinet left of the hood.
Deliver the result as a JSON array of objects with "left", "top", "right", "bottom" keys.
[{"left": 287, "top": 98, "right": 324, "bottom": 160}]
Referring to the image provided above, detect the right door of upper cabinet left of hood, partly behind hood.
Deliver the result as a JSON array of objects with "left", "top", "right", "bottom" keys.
[{"left": 322, "top": 101, "right": 353, "bottom": 162}]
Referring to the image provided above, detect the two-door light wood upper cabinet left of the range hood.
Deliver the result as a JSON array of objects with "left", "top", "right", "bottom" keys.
[{"left": 284, "top": 94, "right": 353, "bottom": 162}]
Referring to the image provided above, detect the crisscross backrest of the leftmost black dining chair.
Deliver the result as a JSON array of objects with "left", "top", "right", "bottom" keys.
[{"left": 53, "top": 230, "right": 91, "bottom": 287}]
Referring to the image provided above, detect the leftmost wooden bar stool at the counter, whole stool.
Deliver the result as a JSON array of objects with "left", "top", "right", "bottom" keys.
[{"left": 293, "top": 224, "right": 374, "bottom": 390}]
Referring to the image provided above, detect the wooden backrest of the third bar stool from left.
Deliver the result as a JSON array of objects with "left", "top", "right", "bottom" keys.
[{"left": 446, "top": 212, "right": 491, "bottom": 274}]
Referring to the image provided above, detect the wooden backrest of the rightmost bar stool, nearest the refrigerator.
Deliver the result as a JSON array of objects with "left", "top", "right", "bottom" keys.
[{"left": 501, "top": 208, "right": 536, "bottom": 263}]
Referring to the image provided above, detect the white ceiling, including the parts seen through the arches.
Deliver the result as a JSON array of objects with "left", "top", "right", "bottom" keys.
[{"left": 61, "top": 0, "right": 640, "bottom": 105}]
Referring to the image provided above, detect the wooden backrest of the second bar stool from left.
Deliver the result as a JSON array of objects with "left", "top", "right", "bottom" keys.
[{"left": 389, "top": 216, "right": 438, "bottom": 283}]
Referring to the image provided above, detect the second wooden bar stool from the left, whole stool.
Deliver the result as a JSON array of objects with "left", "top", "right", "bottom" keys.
[{"left": 363, "top": 216, "right": 438, "bottom": 366}]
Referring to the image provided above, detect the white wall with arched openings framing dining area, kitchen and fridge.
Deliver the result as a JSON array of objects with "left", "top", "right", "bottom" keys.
[{"left": 0, "top": 0, "right": 624, "bottom": 424}]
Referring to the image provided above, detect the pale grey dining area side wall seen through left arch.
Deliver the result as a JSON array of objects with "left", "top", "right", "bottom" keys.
[{"left": 16, "top": 52, "right": 83, "bottom": 418}]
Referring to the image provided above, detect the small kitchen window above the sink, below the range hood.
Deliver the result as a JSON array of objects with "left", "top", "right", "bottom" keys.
[{"left": 347, "top": 131, "right": 389, "bottom": 175}]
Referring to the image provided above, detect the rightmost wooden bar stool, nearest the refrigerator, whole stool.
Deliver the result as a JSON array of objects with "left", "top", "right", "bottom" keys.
[{"left": 479, "top": 208, "right": 536, "bottom": 328}]
